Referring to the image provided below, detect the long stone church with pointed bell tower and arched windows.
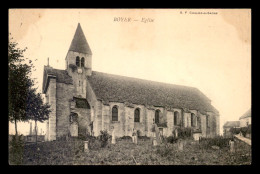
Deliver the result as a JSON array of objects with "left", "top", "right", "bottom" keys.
[{"left": 42, "top": 24, "right": 219, "bottom": 141}]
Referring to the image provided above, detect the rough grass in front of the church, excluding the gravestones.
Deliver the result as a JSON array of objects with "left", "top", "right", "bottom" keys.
[{"left": 10, "top": 135, "right": 251, "bottom": 165}]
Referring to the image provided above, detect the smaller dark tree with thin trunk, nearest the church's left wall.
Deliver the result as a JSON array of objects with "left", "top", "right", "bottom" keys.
[{"left": 26, "top": 88, "right": 51, "bottom": 144}]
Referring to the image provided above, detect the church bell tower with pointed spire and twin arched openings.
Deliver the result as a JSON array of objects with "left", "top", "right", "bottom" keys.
[{"left": 65, "top": 24, "right": 92, "bottom": 98}]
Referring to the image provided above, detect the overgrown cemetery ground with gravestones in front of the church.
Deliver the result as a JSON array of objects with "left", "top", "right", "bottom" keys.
[{"left": 9, "top": 125, "right": 251, "bottom": 165}]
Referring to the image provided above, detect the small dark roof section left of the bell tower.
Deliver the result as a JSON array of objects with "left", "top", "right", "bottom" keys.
[{"left": 42, "top": 66, "right": 73, "bottom": 93}]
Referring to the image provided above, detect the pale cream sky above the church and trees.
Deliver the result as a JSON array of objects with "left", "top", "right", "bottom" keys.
[{"left": 9, "top": 9, "right": 251, "bottom": 134}]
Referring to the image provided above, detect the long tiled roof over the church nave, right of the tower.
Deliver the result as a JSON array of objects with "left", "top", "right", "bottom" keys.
[{"left": 88, "top": 71, "right": 218, "bottom": 114}]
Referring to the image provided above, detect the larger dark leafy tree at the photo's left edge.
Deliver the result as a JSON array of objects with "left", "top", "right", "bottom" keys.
[{"left": 8, "top": 38, "right": 34, "bottom": 135}]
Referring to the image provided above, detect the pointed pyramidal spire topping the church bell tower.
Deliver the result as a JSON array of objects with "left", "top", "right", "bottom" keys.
[{"left": 69, "top": 23, "right": 92, "bottom": 54}]
